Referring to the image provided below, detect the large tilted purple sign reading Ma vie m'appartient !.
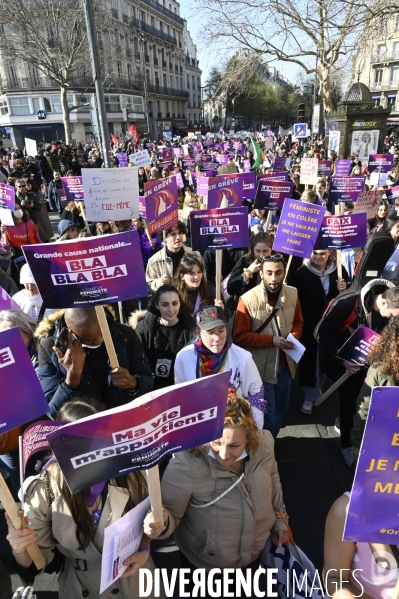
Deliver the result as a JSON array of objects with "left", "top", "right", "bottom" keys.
[{"left": 48, "top": 371, "right": 230, "bottom": 493}]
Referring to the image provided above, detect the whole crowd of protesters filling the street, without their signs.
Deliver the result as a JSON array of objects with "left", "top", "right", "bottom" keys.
[{"left": 0, "top": 125, "right": 399, "bottom": 599}]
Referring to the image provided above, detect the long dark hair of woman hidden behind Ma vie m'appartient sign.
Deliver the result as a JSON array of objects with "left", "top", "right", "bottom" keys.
[{"left": 49, "top": 398, "right": 147, "bottom": 551}]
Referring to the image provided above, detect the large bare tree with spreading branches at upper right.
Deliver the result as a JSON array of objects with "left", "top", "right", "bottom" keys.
[{"left": 195, "top": 0, "right": 392, "bottom": 112}]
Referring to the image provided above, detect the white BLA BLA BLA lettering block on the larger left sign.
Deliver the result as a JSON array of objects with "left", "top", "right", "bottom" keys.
[{"left": 51, "top": 256, "right": 127, "bottom": 285}]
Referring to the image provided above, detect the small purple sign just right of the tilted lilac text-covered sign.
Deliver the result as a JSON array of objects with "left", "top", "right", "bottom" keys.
[{"left": 314, "top": 212, "right": 367, "bottom": 250}]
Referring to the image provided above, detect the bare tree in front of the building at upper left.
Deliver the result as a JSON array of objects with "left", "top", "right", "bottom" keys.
[{"left": 0, "top": 0, "right": 111, "bottom": 143}]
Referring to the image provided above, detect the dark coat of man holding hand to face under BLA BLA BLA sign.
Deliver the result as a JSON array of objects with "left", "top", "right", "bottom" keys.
[{"left": 36, "top": 312, "right": 154, "bottom": 416}]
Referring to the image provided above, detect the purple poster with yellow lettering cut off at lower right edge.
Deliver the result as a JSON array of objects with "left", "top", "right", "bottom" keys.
[{"left": 343, "top": 387, "right": 399, "bottom": 548}]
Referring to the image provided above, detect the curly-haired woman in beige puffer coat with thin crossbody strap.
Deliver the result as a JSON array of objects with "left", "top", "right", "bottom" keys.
[{"left": 144, "top": 391, "right": 288, "bottom": 584}]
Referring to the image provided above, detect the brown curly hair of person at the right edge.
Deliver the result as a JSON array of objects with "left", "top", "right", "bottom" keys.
[{"left": 368, "top": 316, "right": 399, "bottom": 383}]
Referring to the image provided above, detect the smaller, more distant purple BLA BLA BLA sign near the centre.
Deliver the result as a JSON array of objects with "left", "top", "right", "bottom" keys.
[{"left": 190, "top": 208, "right": 248, "bottom": 252}]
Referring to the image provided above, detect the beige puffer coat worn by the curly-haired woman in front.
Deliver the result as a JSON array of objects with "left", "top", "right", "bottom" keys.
[{"left": 160, "top": 431, "right": 288, "bottom": 570}]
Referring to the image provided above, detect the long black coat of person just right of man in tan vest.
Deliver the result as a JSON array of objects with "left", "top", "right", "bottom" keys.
[{"left": 293, "top": 265, "right": 349, "bottom": 387}]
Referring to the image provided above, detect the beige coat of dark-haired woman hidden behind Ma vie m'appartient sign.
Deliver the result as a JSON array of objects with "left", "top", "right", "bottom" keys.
[{"left": 19, "top": 467, "right": 164, "bottom": 599}]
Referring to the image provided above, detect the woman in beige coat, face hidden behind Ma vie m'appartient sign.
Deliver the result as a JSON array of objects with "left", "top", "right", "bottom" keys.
[{"left": 7, "top": 399, "right": 163, "bottom": 599}]
